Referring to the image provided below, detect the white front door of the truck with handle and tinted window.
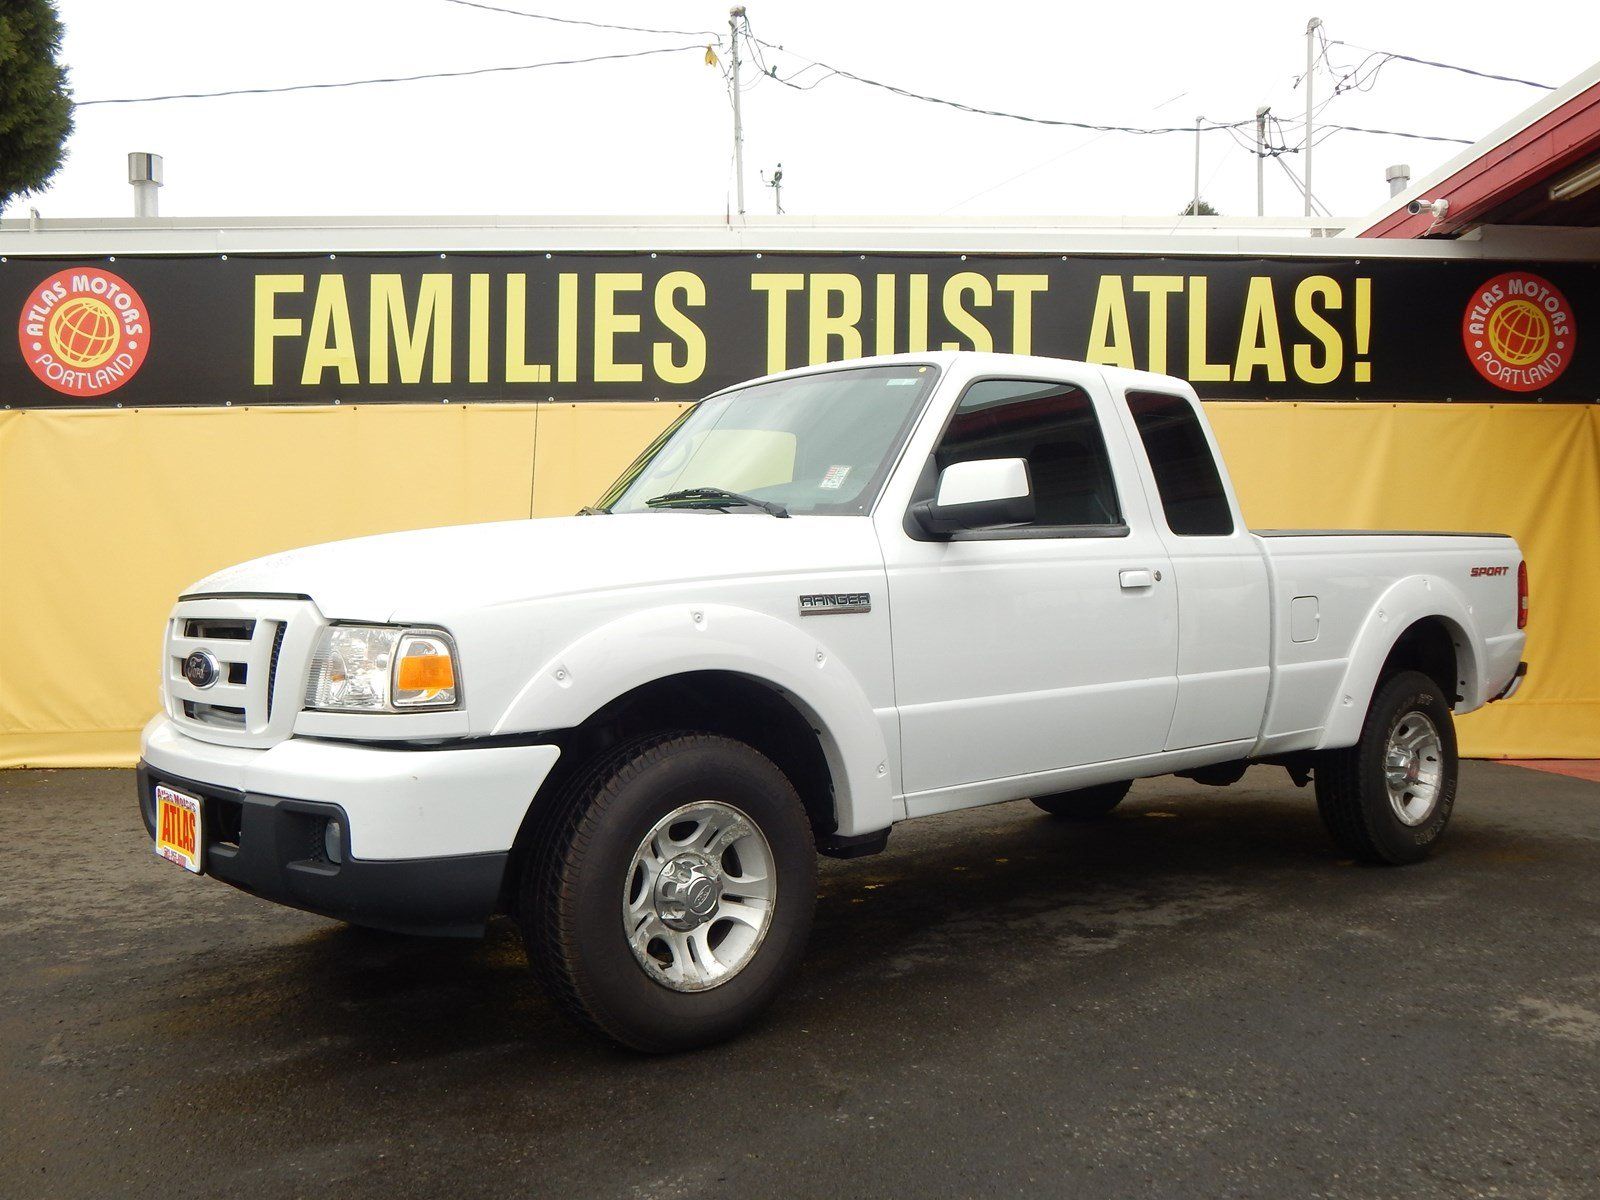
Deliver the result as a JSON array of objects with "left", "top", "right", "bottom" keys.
[{"left": 880, "top": 368, "right": 1178, "bottom": 814}]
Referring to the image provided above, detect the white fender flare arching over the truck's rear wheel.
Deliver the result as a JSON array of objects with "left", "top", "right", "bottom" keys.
[{"left": 1317, "top": 574, "right": 1483, "bottom": 749}]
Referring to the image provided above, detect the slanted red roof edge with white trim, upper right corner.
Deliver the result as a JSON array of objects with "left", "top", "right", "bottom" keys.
[{"left": 1344, "top": 62, "right": 1600, "bottom": 238}]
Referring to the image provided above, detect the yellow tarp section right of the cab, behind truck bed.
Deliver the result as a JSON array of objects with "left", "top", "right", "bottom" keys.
[{"left": 1206, "top": 402, "right": 1600, "bottom": 758}]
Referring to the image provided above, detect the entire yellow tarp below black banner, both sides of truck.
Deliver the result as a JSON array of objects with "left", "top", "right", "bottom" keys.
[{"left": 0, "top": 402, "right": 1600, "bottom": 766}]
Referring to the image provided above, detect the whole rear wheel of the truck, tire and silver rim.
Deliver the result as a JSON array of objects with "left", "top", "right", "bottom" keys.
[{"left": 1315, "top": 670, "right": 1459, "bottom": 866}]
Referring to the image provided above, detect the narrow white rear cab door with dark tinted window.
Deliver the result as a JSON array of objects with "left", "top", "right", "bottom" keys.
[{"left": 1123, "top": 390, "right": 1272, "bottom": 750}]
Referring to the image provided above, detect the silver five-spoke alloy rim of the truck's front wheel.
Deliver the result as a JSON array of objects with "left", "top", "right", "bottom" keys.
[{"left": 622, "top": 800, "right": 778, "bottom": 992}]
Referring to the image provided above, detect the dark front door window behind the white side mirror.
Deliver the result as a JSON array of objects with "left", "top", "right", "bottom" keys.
[{"left": 933, "top": 379, "right": 1122, "bottom": 526}]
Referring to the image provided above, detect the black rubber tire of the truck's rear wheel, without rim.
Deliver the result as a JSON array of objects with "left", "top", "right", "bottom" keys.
[{"left": 1314, "top": 670, "right": 1459, "bottom": 866}]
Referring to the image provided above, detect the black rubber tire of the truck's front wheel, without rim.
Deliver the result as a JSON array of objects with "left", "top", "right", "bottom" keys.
[{"left": 517, "top": 733, "right": 816, "bottom": 1053}]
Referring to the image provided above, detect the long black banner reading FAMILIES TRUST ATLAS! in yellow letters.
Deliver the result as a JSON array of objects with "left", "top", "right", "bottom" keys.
[{"left": 0, "top": 253, "right": 1600, "bottom": 408}]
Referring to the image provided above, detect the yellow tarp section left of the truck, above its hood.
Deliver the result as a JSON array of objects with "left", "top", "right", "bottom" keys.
[{"left": 0, "top": 403, "right": 683, "bottom": 766}]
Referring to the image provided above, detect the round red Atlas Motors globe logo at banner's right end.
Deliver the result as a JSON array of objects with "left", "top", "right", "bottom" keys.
[{"left": 1461, "top": 270, "right": 1578, "bottom": 392}]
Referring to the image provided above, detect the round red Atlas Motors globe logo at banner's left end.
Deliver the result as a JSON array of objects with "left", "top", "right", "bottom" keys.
[{"left": 16, "top": 267, "right": 150, "bottom": 397}]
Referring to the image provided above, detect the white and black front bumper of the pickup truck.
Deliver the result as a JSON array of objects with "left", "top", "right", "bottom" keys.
[{"left": 138, "top": 717, "right": 560, "bottom": 936}]
